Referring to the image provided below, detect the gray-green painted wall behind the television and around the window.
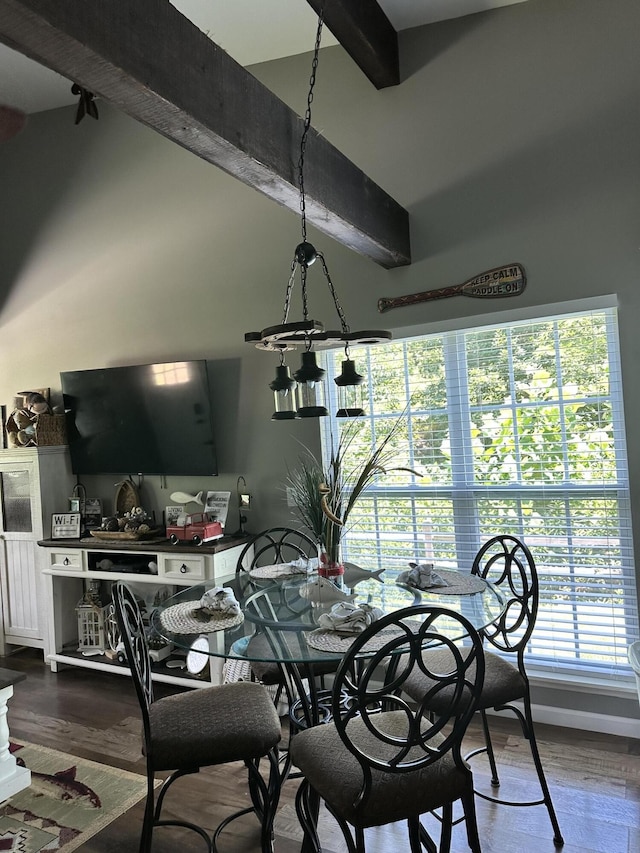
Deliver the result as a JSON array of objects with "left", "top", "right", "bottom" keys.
[{"left": 0, "top": 0, "right": 640, "bottom": 713}]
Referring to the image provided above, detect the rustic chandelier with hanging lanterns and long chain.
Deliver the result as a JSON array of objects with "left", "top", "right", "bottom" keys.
[{"left": 244, "top": 10, "right": 391, "bottom": 420}]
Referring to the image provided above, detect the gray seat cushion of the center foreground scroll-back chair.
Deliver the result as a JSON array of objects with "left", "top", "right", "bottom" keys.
[{"left": 290, "top": 711, "right": 469, "bottom": 828}]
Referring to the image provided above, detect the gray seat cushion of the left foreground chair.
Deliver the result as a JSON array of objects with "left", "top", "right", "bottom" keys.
[{"left": 149, "top": 682, "right": 282, "bottom": 770}]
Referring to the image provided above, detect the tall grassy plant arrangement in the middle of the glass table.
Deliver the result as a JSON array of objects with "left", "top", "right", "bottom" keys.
[{"left": 287, "top": 418, "right": 420, "bottom": 578}]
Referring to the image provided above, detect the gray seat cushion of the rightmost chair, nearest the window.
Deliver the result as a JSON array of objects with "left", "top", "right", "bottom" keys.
[{"left": 402, "top": 651, "right": 526, "bottom": 711}]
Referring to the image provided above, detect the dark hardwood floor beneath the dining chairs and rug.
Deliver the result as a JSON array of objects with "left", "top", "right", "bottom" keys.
[{"left": 0, "top": 650, "right": 640, "bottom": 853}]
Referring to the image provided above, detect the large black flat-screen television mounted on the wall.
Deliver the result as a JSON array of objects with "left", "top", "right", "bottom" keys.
[{"left": 60, "top": 361, "right": 218, "bottom": 476}]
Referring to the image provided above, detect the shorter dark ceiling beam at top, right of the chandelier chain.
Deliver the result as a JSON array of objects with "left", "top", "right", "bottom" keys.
[{"left": 307, "top": 0, "right": 400, "bottom": 89}]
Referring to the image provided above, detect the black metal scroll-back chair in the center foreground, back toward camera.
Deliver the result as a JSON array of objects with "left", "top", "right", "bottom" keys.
[{"left": 290, "top": 604, "right": 484, "bottom": 853}]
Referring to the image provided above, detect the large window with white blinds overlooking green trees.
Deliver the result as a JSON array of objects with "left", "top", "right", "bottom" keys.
[{"left": 324, "top": 309, "right": 638, "bottom": 675}]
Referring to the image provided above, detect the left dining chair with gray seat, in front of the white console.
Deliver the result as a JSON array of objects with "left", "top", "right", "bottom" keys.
[{"left": 112, "top": 581, "right": 281, "bottom": 853}]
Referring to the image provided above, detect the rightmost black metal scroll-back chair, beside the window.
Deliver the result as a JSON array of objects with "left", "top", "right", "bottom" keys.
[{"left": 467, "top": 535, "right": 564, "bottom": 846}]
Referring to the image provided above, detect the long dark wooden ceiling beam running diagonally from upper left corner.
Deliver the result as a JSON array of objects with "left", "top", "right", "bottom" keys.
[{"left": 0, "top": 0, "right": 411, "bottom": 268}]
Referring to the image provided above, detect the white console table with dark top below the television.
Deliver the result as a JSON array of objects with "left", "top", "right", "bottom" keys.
[{"left": 38, "top": 537, "right": 248, "bottom": 687}]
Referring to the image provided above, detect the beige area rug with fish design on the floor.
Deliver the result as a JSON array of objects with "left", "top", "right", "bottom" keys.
[{"left": 0, "top": 741, "right": 147, "bottom": 853}]
